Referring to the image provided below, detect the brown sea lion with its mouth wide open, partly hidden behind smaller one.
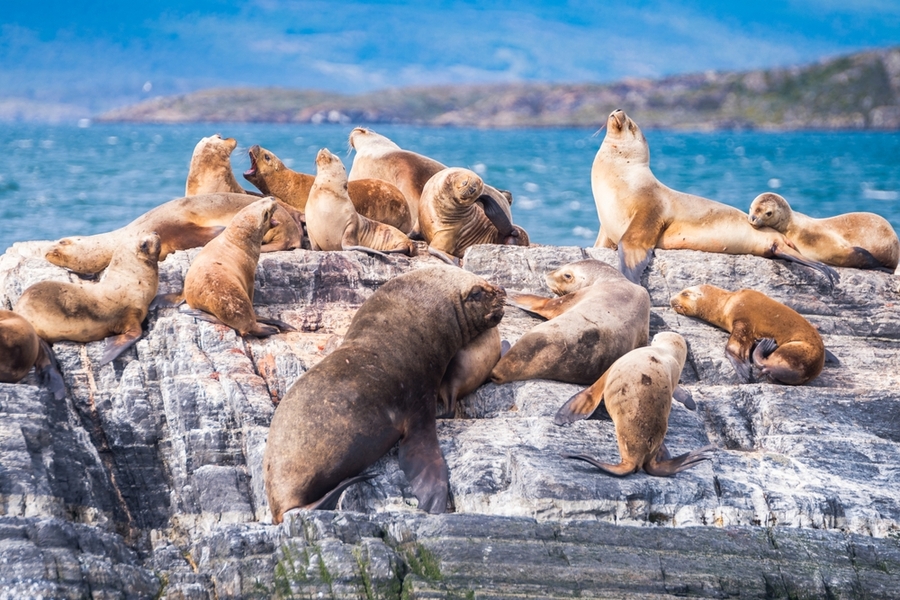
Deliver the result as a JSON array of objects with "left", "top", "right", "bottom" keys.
[{"left": 244, "top": 146, "right": 413, "bottom": 233}]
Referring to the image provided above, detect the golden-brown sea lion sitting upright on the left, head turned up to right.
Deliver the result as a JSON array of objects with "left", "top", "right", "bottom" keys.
[{"left": 182, "top": 198, "right": 294, "bottom": 337}]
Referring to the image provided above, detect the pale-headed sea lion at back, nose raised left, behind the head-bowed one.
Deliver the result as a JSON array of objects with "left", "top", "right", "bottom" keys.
[{"left": 348, "top": 127, "right": 528, "bottom": 246}]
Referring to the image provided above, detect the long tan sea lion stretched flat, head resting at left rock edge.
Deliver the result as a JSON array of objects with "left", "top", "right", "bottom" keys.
[{"left": 45, "top": 193, "right": 302, "bottom": 274}]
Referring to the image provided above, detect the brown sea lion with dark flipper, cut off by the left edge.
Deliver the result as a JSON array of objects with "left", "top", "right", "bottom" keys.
[{"left": 0, "top": 310, "right": 66, "bottom": 400}]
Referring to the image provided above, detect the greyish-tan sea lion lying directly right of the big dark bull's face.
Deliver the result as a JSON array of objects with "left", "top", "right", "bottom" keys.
[{"left": 491, "top": 260, "right": 650, "bottom": 385}]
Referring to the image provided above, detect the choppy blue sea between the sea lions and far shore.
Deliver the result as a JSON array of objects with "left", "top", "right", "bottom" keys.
[{"left": 0, "top": 123, "right": 900, "bottom": 251}]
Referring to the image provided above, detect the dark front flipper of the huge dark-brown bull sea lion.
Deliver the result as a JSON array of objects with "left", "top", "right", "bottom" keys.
[{"left": 399, "top": 414, "right": 450, "bottom": 514}]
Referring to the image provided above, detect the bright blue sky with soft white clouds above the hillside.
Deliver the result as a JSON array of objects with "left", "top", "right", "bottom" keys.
[{"left": 0, "top": 0, "right": 900, "bottom": 110}]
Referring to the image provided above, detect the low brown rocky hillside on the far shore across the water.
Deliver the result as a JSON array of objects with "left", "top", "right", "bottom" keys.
[{"left": 98, "top": 48, "right": 900, "bottom": 130}]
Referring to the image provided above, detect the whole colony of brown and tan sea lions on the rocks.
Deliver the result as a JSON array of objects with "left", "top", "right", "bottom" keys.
[{"left": 0, "top": 115, "right": 897, "bottom": 522}]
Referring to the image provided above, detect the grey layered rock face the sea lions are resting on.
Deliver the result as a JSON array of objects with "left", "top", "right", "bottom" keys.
[{"left": 0, "top": 242, "right": 900, "bottom": 598}]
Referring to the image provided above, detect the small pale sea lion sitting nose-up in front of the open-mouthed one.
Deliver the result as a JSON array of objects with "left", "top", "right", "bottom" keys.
[{"left": 306, "top": 148, "right": 416, "bottom": 256}]
